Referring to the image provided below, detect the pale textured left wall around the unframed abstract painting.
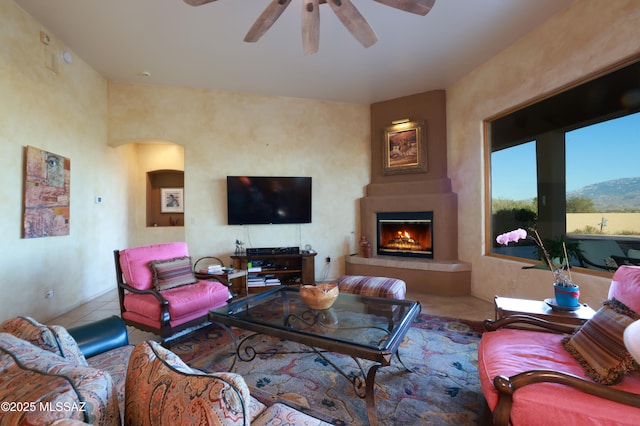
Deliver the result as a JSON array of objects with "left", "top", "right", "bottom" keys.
[{"left": 0, "top": 0, "right": 131, "bottom": 321}]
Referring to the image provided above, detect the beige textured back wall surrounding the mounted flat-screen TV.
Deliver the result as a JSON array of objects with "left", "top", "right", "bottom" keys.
[{"left": 108, "top": 82, "right": 370, "bottom": 279}]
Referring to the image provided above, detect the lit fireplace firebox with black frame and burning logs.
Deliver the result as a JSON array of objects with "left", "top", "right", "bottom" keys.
[{"left": 376, "top": 211, "right": 433, "bottom": 259}]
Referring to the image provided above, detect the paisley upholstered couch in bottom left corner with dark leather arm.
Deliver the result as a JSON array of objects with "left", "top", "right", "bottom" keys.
[{"left": 0, "top": 317, "right": 133, "bottom": 425}]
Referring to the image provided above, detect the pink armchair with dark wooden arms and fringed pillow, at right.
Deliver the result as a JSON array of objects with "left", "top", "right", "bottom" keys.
[{"left": 478, "top": 266, "right": 640, "bottom": 426}]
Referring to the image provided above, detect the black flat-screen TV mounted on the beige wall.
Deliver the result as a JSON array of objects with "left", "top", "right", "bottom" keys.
[{"left": 227, "top": 176, "right": 311, "bottom": 225}]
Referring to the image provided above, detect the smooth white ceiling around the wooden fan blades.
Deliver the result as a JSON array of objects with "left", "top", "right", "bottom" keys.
[{"left": 15, "top": 0, "right": 573, "bottom": 104}]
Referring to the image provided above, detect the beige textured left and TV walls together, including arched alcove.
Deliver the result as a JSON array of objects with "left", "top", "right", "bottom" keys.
[{"left": 0, "top": 0, "right": 370, "bottom": 321}]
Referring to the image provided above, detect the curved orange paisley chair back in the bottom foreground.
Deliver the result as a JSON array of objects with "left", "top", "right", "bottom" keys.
[{"left": 124, "top": 341, "right": 250, "bottom": 425}]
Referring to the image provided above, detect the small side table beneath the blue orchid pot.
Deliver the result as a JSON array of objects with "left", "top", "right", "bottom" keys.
[{"left": 493, "top": 296, "right": 596, "bottom": 325}]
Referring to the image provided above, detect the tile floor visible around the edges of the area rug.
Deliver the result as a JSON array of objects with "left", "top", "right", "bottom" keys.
[{"left": 47, "top": 289, "right": 494, "bottom": 344}]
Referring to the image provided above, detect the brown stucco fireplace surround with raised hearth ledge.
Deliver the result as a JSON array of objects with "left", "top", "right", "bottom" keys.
[{"left": 345, "top": 90, "right": 471, "bottom": 296}]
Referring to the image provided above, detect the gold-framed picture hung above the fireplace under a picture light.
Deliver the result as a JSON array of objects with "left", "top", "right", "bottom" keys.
[{"left": 383, "top": 121, "right": 427, "bottom": 175}]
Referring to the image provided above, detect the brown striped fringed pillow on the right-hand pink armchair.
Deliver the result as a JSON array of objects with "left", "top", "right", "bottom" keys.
[{"left": 562, "top": 299, "right": 640, "bottom": 385}]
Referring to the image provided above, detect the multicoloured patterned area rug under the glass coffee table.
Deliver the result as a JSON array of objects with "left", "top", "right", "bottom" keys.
[{"left": 172, "top": 314, "right": 484, "bottom": 426}]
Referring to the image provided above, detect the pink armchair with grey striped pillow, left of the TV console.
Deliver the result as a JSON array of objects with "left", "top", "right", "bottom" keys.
[{"left": 114, "top": 242, "right": 229, "bottom": 347}]
